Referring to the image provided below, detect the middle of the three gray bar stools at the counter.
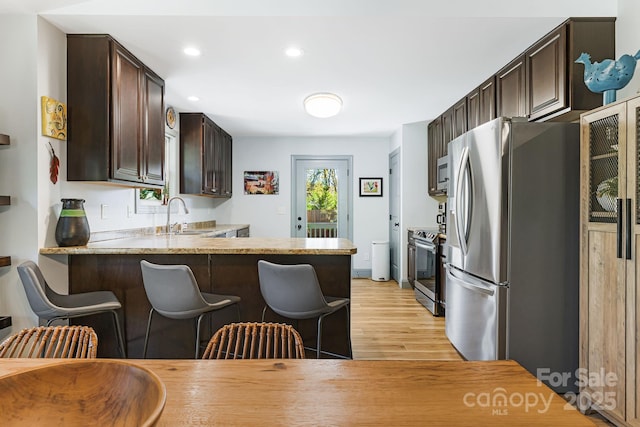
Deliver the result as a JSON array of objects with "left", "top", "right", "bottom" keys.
[{"left": 140, "top": 260, "right": 240, "bottom": 359}]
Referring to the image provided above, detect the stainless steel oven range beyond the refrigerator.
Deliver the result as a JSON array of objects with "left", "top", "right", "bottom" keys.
[{"left": 408, "top": 230, "right": 446, "bottom": 316}]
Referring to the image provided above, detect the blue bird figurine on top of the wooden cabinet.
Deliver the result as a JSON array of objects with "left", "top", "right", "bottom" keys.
[{"left": 575, "top": 50, "right": 640, "bottom": 104}]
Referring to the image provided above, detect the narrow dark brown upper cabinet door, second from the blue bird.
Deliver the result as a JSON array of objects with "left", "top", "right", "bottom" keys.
[{"left": 496, "top": 55, "right": 528, "bottom": 117}]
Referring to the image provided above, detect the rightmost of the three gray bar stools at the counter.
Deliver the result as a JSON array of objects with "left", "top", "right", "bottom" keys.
[{"left": 258, "top": 260, "right": 351, "bottom": 359}]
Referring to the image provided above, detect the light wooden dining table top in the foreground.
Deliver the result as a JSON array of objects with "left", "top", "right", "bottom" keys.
[{"left": 0, "top": 359, "right": 594, "bottom": 427}]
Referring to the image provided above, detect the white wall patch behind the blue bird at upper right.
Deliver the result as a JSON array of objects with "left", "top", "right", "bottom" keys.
[{"left": 616, "top": 0, "right": 640, "bottom": 99}]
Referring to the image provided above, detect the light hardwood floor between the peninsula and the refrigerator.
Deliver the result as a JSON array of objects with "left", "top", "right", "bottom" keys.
[{"left": 351, "top": 279, "right": 613, "bottom": 427}]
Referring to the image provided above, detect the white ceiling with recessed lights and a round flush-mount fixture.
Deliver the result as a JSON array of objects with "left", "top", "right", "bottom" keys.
[{"left": 0, "top": 0, "right": 617, "bottom": 137}]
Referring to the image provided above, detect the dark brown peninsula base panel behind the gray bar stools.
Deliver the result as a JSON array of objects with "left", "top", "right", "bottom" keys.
[{"left": 69, "top": 254, "right": 351, "bottom": 359}]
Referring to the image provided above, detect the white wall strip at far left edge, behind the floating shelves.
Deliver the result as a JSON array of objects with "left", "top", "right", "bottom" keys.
[{"left": 0, "top": 15, "right": 39, "bottom": 334}]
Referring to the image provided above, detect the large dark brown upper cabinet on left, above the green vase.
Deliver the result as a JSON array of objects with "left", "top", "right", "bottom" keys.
[{"left": 67, "top": 34, "right": 165, "bottom": 187}]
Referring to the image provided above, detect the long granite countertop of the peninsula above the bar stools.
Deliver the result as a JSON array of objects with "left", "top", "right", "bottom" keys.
[{"left": 40, "top": 236, "right": 357, "bottom": 255}]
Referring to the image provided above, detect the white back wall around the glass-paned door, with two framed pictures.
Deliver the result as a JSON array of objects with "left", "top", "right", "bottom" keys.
[{"left": 216, "top": 137, "right": 390, "bottom": 269}]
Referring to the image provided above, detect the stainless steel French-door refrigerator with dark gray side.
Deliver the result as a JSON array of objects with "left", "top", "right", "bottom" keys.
[{"left": 445, "top": 118, "right": 580, "bottom": 392}]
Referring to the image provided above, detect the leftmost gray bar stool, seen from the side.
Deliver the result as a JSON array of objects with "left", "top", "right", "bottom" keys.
[{"left": 18, "top": 261, "right": 127, "bottom": 358}]
